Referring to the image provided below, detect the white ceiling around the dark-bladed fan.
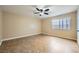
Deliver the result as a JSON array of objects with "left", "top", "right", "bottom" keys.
[{"left": 0, "top": 5, "right": 78, "bottom": 18}]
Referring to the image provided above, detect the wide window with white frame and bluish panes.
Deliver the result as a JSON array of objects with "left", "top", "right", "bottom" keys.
[{"left": 52, "top": 17, "right": 71, "bottom": 30}]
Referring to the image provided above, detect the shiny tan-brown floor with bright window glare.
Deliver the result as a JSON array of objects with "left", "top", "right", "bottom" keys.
[{"left": 0, "top": 35, "right": 79, "bottom": 53}]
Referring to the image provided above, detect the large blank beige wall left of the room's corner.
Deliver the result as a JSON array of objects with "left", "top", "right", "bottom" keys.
[{"left": 3, "top": 12, "right": 41, "bottom": 38}]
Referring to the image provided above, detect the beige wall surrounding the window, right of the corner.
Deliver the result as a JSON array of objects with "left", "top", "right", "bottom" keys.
[{"left": 42, "top": 12, "right": 76, "bottom": 40}]
